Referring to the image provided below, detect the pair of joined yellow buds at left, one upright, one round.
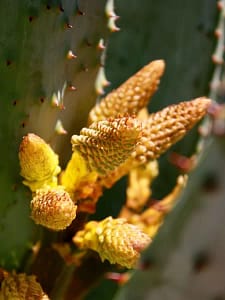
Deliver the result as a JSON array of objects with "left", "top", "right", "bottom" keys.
[{"left": 19, "top": 133, "right": 77, "bottom": 230}]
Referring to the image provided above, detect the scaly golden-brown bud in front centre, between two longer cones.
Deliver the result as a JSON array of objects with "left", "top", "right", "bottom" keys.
[{"left": 71, "top": 117, "right": 141, "bottom": 174}]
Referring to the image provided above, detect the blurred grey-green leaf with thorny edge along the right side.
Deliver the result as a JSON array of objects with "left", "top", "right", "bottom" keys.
[{"left": 114, "top": 1, "right": 225, "bottom": 300}]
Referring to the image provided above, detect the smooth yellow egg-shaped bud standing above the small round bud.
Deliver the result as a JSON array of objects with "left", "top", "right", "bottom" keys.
[{"left": 19, "top": 133, "right": 60, "bottom": 191}]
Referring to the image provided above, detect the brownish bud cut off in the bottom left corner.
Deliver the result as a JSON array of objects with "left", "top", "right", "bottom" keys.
[{"left": 0, "top": 273, "right": 49, "bottom": 300}]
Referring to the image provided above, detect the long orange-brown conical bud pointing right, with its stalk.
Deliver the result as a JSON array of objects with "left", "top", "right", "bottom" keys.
[{"left": 101, "top": 97, "right": 211, "bottom": 187}]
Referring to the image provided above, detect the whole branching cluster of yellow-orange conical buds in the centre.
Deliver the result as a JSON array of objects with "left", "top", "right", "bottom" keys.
[{"left": 19, "top": 60, "right": 211, "bottom": 268}]
